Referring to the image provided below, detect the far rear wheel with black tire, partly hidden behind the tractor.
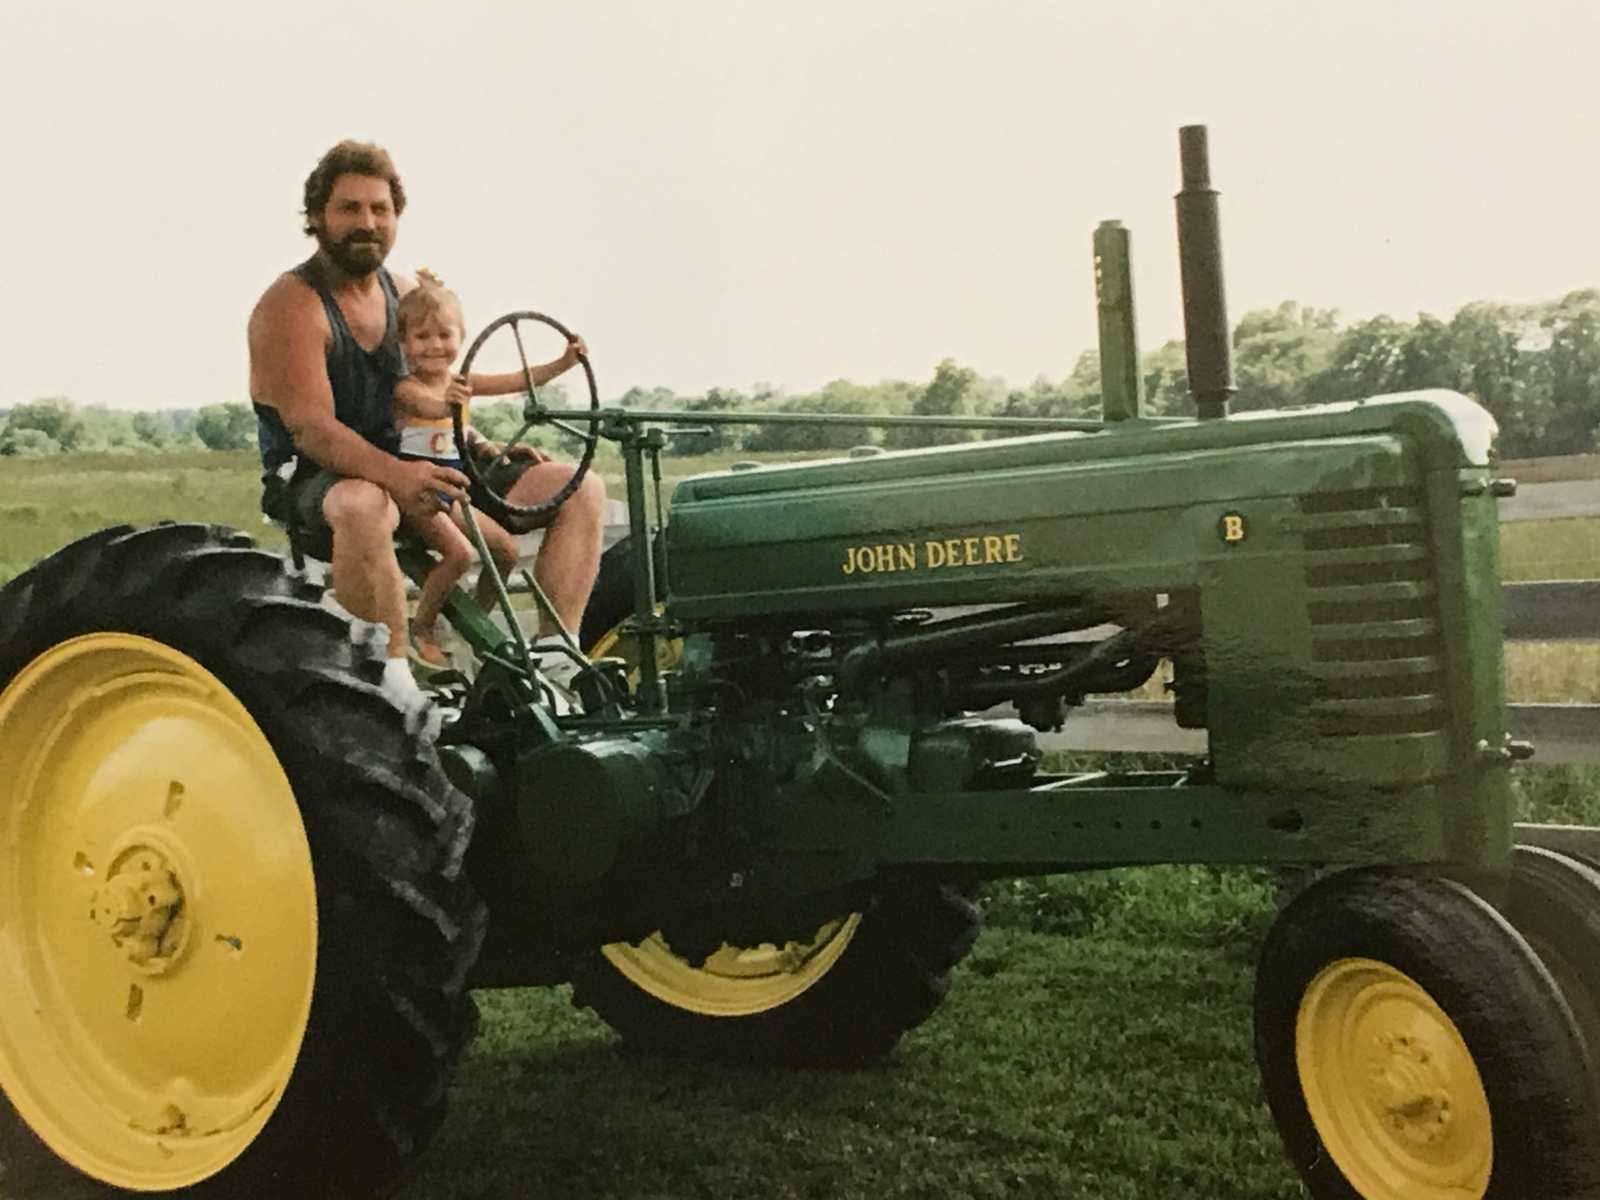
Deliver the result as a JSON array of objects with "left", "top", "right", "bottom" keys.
[{"left": 573, "top": 541, "right": 982, "bottom": 1066}]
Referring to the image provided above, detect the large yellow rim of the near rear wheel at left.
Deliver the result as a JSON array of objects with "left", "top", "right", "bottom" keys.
[{"left": 0, "top": 634, "right": 317, "bottom": 1190}]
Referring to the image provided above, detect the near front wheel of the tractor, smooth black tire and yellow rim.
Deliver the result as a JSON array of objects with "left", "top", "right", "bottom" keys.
[{"left": 1256, "top": 869, "right": 1600, "bottom": 1200}]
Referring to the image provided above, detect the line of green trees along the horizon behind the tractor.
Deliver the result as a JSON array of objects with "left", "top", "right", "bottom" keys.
[{"left": 0, "top": 288, "right": 1600, "bottom": 458}]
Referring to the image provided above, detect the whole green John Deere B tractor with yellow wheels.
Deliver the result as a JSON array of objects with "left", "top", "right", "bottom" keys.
[{"left": 0, "top": 126, "right": 1600, "bottom": 1200}]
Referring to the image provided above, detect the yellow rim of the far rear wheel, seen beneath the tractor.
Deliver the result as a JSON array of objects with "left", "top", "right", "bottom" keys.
[{"left": 589, "top": 614, "right": 861, "bottom": 1016}]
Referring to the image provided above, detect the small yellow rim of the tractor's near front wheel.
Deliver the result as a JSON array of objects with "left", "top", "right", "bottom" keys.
[{"left": 1294, "top": 958, "right": 1494, "bottom": 1200}]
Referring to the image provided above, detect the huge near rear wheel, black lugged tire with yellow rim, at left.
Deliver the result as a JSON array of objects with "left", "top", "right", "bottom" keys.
[{"left": 0, "top": 525, "right": 485, "bottom": 1197}]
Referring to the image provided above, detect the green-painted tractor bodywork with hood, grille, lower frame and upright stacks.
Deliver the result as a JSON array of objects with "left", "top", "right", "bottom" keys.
[{"left": 419, "top": 130, "right": 1542, "bottom": 912}]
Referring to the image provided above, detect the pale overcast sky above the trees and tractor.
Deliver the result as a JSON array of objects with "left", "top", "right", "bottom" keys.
[{"left": 0, "top": 0, "right": 1600, "bottom": 408}]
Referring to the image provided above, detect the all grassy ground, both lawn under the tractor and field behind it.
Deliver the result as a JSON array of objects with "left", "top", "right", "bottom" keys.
[{"left": 0, "top": 453, "right": 1600, "bottom": 1200}]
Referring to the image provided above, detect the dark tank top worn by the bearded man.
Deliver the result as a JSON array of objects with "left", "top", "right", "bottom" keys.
[{"left": 256, "top": 259, "right": 405, "bottom": 472}]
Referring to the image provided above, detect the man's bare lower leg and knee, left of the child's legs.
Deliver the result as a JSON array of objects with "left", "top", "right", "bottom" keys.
[{"left": 322, "top": 478, "right": 406, "bottom": 658}]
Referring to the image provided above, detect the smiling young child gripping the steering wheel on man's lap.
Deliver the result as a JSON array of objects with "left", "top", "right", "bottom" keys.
[{"left": 394, "top": 270, "right": 587, "bottom": 667}]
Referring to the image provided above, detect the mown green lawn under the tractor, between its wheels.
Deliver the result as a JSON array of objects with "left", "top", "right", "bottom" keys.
[{"left": 0, "top": 930, "right": 1304, "bottom": 1200}]
